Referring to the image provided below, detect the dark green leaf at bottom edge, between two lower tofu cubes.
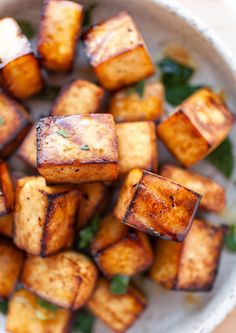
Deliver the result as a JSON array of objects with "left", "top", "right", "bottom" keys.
[{"left": 73, "top": 308, "right": 95, "bottom": 333}]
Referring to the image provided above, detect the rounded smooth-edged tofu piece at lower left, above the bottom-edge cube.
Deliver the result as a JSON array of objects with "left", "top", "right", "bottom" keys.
[{"left": 22, "top": 251, "right": 97, "bottom": 310}]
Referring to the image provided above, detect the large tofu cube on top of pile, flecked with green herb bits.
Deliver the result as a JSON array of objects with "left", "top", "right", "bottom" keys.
[{"left": 36, "top": 114, "right": 118, "bottom": 184}]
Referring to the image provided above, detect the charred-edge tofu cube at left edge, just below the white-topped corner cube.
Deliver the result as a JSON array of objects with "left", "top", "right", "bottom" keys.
[{"left": 0, "top": 92, "right": 32, "bottom": 158}]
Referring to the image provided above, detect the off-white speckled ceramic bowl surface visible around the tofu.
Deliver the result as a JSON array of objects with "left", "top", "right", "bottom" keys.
[{"left": 0, "top": 0, "right": 236, "bottom": 333}]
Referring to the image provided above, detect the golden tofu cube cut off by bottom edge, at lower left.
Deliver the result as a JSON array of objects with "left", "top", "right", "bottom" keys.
[{"left": 6, "top": 289, "right": 72, "bottom": 333}]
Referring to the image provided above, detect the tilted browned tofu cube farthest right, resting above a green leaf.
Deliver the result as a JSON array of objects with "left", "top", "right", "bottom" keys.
[{"left": 157, "top": 89, "right": 234, "bottom": 167}]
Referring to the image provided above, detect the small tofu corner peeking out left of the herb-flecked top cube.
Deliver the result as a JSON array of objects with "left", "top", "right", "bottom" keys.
[{"left": 17, "top": 126, "right": 37, "bottom": 169}]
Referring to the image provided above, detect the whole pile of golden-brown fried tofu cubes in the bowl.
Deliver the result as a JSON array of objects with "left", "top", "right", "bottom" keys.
[{"left": 0, "top": 0, "right": 234, "bottom": 333}]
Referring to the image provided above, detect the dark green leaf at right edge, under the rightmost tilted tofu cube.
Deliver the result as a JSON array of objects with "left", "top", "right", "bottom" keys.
[{"left": 206, "top": 138, "right": 234, "bottom": 178}]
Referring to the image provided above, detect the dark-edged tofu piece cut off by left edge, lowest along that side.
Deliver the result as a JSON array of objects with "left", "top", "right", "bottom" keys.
[{"left": 0, "top": 239, "right": 24, "bottom": 298}]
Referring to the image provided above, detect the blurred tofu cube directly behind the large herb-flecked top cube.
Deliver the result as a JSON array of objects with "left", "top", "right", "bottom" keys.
[{"left": 51, "top": 80, "right": 104, "bottom": 116}]
